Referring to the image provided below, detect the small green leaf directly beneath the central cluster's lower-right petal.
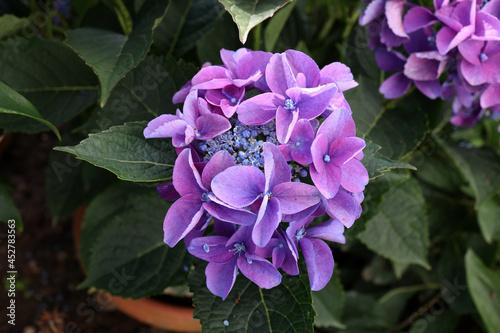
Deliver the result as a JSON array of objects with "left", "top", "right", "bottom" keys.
[{"left": 312, "top": 269, "right": 345, "bottom": 328}]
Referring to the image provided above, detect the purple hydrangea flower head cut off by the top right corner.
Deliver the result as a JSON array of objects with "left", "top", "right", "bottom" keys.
[{"left": 359, "top": 0, "right": 500, "bottom": 130}]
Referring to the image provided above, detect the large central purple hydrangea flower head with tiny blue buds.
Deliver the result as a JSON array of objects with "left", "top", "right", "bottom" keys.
[{"left": 144, "top": 49, "right": 368, "bottom": 299}]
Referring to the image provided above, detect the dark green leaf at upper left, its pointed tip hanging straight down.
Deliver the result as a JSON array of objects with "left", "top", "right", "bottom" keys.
[{"left": 65, "top": 0, "right": 168, "bottom": 106}]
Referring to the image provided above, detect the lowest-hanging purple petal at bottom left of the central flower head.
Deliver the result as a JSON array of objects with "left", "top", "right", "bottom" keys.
[{"left": 205, "top": 257, "right": 238, "bottom": 300}]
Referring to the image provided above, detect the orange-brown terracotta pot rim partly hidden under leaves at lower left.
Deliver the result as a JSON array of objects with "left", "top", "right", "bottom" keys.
[{"left": 73, "top": 207, "right": 201, "bottom": 332}]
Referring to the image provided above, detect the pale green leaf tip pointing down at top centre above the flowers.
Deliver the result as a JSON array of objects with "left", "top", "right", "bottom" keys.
[{"left": 219, "top": 0, "right": 290, "bottom": 44}]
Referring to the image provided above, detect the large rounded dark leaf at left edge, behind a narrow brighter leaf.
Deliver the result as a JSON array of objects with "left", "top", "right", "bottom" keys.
[{"left": 0, "top": 38, "right": 98, "bottom": 133}]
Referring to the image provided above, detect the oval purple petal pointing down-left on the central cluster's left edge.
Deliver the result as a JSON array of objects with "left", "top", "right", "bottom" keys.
[{"left": 163, "top": 194, "right": 205, "bottom": 247}]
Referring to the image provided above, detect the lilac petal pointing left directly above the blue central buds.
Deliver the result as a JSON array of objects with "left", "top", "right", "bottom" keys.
[{"left": 236, "top": 93, "right": 285, "bottom": 125}]
